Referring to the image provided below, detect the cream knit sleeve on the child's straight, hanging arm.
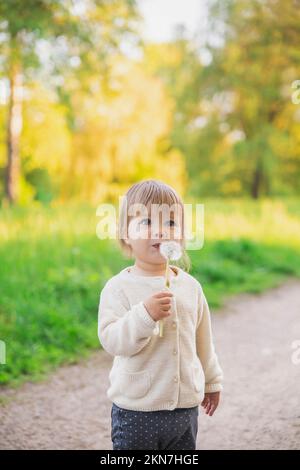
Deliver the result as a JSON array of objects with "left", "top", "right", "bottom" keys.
[{"left": 196, "top": 287, "right": 223, "bottom": 393}]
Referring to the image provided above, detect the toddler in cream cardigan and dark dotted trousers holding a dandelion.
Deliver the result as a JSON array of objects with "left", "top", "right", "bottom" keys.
[{"left": 98, "top": 180, "right": 223, "bottom": 450}]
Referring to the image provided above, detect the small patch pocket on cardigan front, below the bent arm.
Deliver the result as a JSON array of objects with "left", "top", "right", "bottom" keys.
[{"left": 119, "top": 370, "right": 151, "bottom": 398}]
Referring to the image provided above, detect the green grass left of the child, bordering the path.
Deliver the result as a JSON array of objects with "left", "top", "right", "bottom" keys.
[{"left": 0, "top": 211, "right": 124, "bottom": 384}]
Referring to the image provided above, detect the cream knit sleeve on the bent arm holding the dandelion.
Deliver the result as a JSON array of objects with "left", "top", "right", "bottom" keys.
[{"left": 98, "top": 283, "right": 157, "bottom": 356}]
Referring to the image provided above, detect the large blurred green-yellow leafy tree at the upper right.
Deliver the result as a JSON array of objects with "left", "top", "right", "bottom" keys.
[{"left": 202, "top": 0, "right": 300, "bottom": 198}]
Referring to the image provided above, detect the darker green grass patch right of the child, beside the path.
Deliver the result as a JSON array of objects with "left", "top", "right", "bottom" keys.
[{"left": 191, "top": 239, "right": 300, "bottom": 308}]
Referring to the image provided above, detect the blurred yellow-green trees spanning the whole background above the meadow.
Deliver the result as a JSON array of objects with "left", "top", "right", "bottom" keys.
[{"left": 0, "top": 0, "right": 300, "bottom": 204}]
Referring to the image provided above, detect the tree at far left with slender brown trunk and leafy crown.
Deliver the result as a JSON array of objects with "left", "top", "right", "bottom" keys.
[{"left": 0, "top": 0, "right": 138, "bottom": 203}]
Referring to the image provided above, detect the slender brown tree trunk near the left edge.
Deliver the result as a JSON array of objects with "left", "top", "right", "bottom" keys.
[{"left": 5, "top": 64, "right": 23, "bottom": 204}]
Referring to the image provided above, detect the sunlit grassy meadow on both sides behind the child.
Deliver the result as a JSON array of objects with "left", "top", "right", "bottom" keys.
[{"left": 0, "top": 199, "right": 300, "bottom": 386}]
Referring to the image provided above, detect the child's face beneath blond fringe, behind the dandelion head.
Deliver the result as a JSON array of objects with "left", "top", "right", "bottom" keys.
[{"left": 125, "top": 208, "right": 183, "bottom": 264}]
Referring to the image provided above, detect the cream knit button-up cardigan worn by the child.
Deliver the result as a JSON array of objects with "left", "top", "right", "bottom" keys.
[{"left": 98, "top": 266, "right": 223, "bottom": 411}]
